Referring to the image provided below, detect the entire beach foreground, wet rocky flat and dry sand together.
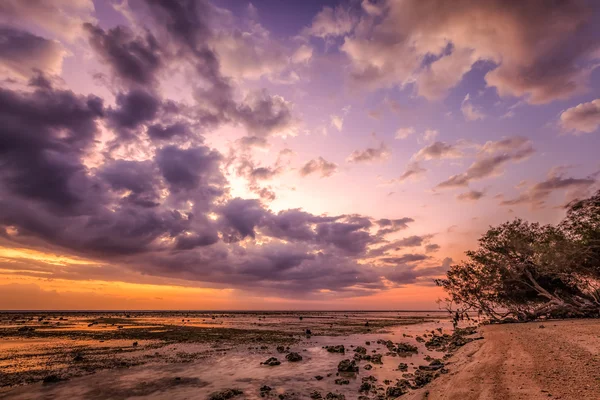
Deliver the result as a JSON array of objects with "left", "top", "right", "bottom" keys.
[{"left": 0, "top": 312, "right": 600, "bottom": 400}]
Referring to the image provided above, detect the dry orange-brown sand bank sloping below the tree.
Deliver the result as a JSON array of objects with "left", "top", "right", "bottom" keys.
[{"left": 406, "top": 320, "right": 600, "bottom": 400}]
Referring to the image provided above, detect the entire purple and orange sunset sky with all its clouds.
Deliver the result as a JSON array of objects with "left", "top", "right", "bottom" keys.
[{"left": 0, "top": 0, "right": 600, "bottom": 310}]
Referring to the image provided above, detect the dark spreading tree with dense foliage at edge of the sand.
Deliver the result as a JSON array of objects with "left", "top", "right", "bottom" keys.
[{"left": 436, "top": 191, "right": 600, "bottom": 320}]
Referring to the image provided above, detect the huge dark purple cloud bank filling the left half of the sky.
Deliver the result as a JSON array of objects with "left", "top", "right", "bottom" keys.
[{"left": 0, "top": 4, "right": 446, "bottom": 296}]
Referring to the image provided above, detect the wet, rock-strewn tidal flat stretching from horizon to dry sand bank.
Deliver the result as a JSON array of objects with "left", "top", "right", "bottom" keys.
[{"left": 0, "top": 311, "right": 478, "bottom": 400}]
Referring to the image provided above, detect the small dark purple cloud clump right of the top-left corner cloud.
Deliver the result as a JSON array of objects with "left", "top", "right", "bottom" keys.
[{"left": 84, "top": 23, "right": 162, "bottom": 85}]
